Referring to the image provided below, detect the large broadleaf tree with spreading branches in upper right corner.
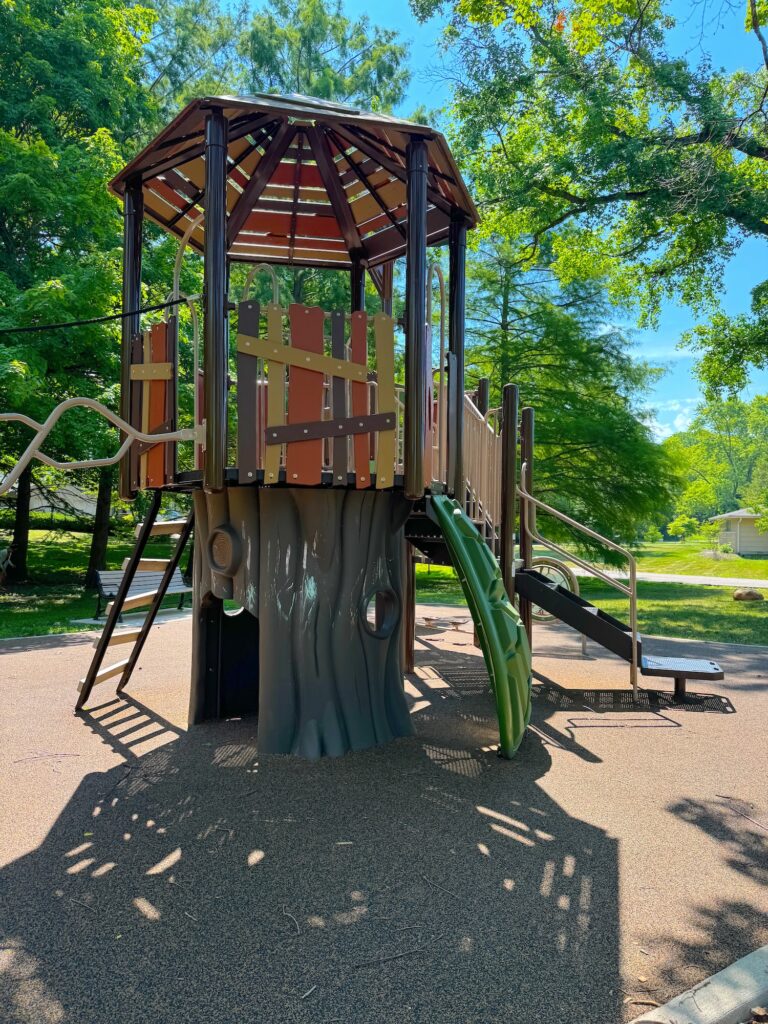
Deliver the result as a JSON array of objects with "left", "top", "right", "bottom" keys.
[{"left": 412, "top": 0, "right": 768, "bottom": 392}]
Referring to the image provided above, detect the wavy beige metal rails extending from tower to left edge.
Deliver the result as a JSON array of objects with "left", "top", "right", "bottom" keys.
[{"left": 0, "top": 398, "right": 198, "bottom": 495}]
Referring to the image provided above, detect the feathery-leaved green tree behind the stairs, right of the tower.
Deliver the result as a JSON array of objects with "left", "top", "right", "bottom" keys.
[{"left": 467, "top": 238, "right": 676, "bottom": 542}]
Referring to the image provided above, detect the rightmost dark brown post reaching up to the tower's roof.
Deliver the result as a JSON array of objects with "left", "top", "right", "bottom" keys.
[{"left": 445, "top": 211, "right": 467, "bottom": 497}]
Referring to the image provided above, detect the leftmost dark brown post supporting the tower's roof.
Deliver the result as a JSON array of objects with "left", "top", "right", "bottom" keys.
[{"left": 120, "top": 178, "right": 144, "bottom": 499}]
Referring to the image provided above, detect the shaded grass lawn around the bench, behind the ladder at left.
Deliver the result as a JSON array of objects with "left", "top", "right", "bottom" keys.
[{"left": 0, "top": 529, "right": 185, "bottom": 639}]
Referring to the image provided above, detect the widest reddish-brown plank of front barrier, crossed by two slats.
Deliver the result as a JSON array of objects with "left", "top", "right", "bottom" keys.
[{"left": 286, "top": 303, "right": 325, "bottom": 486}]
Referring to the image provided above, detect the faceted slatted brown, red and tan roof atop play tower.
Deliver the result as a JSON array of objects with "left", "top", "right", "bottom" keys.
[{"left": 110, "top": 93, "right": 478, "bottom": 268}]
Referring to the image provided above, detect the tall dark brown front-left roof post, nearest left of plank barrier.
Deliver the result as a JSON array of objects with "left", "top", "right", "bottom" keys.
[{"left": 203, "top": 108, "right": 229, "bottom": 490}]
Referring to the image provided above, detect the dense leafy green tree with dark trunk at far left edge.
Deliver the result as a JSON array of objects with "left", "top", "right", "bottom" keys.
[{"left": 0, "top": 0, "right": 153, "bottom": 579}]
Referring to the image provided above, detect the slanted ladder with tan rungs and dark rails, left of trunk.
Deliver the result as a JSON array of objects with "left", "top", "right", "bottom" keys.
[{"left": 75, "top": 490, "right": 195, "bottom": 711}]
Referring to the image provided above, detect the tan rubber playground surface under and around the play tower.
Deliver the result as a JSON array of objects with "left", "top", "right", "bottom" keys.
[{"left": 0, "top": 606, "right": 768, "bottom": 1024}]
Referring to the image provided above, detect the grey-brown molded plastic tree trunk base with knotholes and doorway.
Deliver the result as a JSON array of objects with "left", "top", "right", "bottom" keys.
[{"left": 190, "top": 487, "right": 413, "bottom": 758}]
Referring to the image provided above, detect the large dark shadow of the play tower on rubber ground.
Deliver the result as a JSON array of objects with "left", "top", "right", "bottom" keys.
[{"left": 0, "top": 677, "right": 622, "bottom": 1024}]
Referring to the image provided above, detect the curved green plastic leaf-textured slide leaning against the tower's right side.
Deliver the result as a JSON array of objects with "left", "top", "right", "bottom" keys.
[{"left": 428, "top": 495, "right": 530, "bottom": 758}]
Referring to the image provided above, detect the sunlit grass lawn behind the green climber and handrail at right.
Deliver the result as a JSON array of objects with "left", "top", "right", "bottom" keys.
[{"left": 416, "top": 565, "right": 768, "bottom": 644}]
